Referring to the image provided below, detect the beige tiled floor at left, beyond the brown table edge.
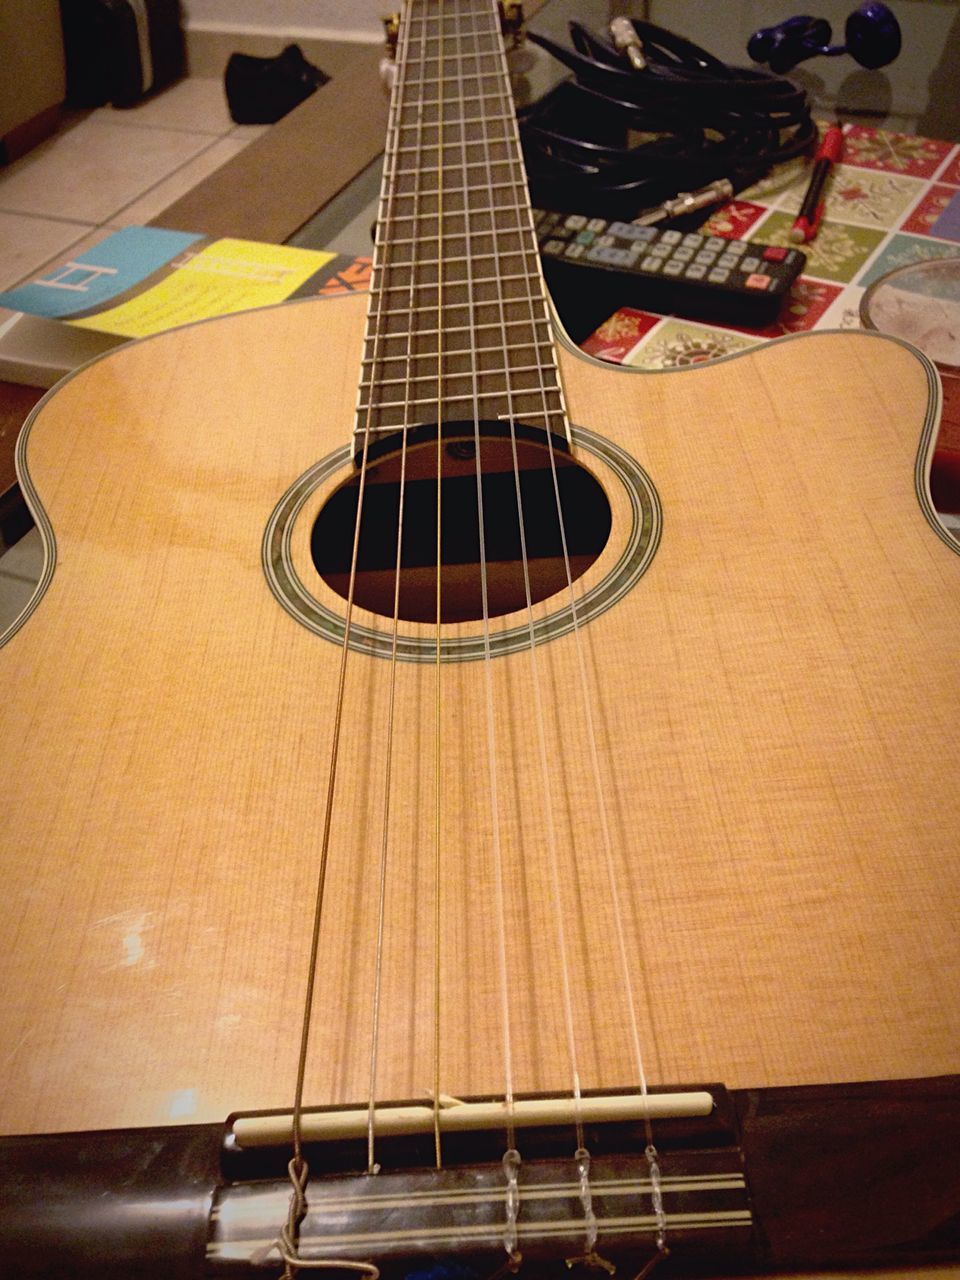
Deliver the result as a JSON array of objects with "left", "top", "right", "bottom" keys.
[{"left": 0, "top": 78, "right": 265, "bottom": 632}]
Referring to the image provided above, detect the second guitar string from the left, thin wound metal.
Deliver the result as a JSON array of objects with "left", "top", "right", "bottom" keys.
[{"left": 366, "top": 0, "right": 422, "bottom": 1174}]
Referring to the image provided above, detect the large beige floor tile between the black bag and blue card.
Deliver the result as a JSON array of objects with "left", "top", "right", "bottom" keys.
[{"left": 0, "top": 116, "right": 217, "bottom": 223}]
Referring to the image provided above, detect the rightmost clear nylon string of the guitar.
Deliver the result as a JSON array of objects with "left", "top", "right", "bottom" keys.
[{"left": 499, "top": 0, "right": 667, "bottom": 1253}]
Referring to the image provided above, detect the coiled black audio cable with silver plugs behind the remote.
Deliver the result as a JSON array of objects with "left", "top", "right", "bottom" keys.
[{"left": 520, "top": 19, "right": 817, "bottom": 218}]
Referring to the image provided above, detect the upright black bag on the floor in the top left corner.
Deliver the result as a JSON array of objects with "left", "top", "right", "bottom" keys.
[{"left": 60, "top": 0, "right": 186, "bottom": 106}]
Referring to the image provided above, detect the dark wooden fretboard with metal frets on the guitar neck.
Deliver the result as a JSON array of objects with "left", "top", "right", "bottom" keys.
[{"left": 356, "top": 0, "right": 566, "bottom": 444}]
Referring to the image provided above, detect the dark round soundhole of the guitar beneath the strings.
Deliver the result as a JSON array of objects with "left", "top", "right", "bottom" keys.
[{"left": 311, "top": 422, "right": 612, "bottom": 622}]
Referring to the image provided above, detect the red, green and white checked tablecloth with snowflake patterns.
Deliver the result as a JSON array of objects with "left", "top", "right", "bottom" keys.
[{"left": 582, "top": 124, "right": 960, "bottom": 512}]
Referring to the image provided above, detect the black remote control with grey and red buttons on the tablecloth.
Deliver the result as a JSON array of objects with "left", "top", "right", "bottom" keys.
[{"left": 534, "top": 210, "right": 806, "bottom": 340}]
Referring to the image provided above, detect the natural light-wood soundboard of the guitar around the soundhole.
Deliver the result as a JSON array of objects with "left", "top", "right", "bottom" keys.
[{"left": 0, "top": 298, "right": 960, "bottom": 1157}]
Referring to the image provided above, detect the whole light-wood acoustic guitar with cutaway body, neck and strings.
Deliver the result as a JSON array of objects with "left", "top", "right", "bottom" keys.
[{"left": 0, "top": 0, "right": 960, "bottom": 1280}]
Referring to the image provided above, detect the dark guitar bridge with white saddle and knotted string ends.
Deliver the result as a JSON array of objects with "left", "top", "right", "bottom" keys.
[{"left": 207, "top": 1085, "right": 753, "bottom": 1276}]
